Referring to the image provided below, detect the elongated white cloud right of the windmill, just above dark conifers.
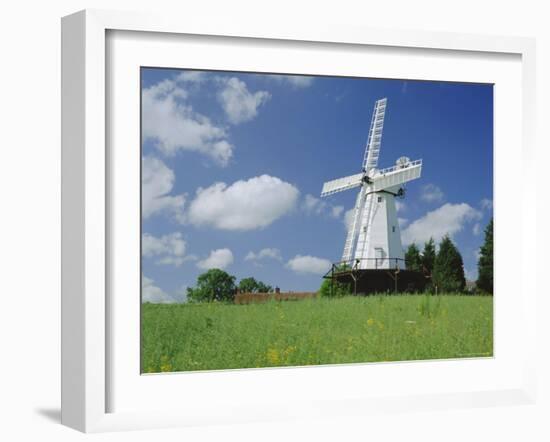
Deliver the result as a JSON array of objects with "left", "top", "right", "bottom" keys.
[{"left": 401, "top": 203, "right": 481, "bottom": 244}]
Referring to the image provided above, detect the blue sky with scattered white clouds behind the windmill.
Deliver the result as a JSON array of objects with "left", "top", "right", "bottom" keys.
[{"left": 141, "top": 68, "right": 493, "bottom": 302}]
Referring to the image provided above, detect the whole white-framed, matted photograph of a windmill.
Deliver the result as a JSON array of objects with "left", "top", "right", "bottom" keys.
[{"left": 62, "top": 11, "right": 536, "bottom": 432}]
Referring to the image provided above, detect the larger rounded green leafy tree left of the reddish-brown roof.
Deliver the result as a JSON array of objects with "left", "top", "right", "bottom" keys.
[{"left": 187, "top": 269, "right": 236, "bottom": 302}]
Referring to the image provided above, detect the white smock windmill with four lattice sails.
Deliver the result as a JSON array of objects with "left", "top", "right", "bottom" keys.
[{"left": 321, "top": 98, "right": 422, "bottom": 270}]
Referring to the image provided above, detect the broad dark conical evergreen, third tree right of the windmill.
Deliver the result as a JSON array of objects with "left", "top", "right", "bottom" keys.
[{"left": 432, "top": 235, "right": 466, "bottom": 293}]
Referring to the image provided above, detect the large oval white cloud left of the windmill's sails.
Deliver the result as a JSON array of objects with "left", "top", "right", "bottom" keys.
[{"left": 187, "top": 175, "right": 300, "bottom": 230}]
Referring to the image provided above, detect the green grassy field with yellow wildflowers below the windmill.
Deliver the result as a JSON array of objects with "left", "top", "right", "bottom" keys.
[{"left": 141, "top": 295, "right": 493, "bottom": 373}]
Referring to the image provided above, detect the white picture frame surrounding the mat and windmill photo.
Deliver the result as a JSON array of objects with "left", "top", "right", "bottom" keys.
[{"left": 62, "top": 10, "right": 537, "bottom": 432}]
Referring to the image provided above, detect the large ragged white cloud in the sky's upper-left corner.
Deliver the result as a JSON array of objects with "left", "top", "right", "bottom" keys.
[{"left": 142, "top": 76, "right": 233, "bottom": 166}]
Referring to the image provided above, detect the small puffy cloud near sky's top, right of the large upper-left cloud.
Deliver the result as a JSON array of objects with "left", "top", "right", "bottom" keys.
[{"left": 218, "top": 77, "right": 271, "bottom": 124}]
